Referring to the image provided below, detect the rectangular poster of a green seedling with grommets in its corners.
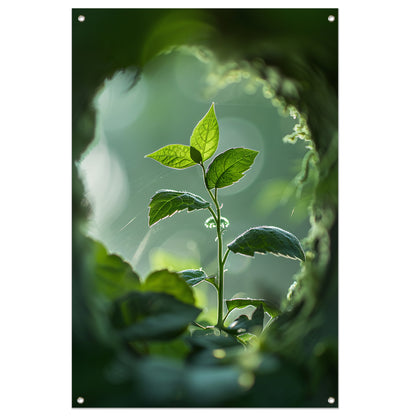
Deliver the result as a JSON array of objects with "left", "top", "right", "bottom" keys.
[{"left": 72, "top": 9, "right": 338, "bottom": 408}]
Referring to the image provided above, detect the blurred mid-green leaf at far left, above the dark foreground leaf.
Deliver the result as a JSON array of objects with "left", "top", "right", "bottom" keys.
[{"left": 93, "top": 241, "right": 140, "bottom": 300}]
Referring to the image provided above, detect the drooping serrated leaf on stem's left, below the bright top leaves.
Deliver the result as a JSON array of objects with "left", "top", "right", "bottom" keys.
[{"left": 149, "top": 189, "right": 209, "bottom": 226}]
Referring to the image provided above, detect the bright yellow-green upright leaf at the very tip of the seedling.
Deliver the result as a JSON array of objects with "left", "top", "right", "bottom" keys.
[{"left": 190, "top": 103, "right": 220, "bottom": 162}]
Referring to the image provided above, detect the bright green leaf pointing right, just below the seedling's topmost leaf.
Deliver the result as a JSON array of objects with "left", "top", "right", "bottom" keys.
[{"left": 206, "top": 147, "right": 259, "bottom": 189}]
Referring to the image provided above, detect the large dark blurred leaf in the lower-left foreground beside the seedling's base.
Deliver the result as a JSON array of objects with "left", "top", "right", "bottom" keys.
[{"left": 112, "top": 292, "right": 201, "bottom": 341}]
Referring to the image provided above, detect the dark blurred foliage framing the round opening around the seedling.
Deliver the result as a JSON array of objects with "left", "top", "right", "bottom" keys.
[{"left": 72, "top": 9, "right": 338, "bottom": 407}]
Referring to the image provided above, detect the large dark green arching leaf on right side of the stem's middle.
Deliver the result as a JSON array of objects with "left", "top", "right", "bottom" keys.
[{"left": 228, "top": 226, "right": 305, "bottom": 261}]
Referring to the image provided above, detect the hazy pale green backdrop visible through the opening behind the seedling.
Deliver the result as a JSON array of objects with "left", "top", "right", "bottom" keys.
[{"left": 79, "top": 51, "right": 309, "bottom": 324}]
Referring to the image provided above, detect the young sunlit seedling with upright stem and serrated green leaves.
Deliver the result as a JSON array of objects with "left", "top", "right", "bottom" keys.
[{"left": 146, "top": 103, "right": 305, "bottom": 335}]
